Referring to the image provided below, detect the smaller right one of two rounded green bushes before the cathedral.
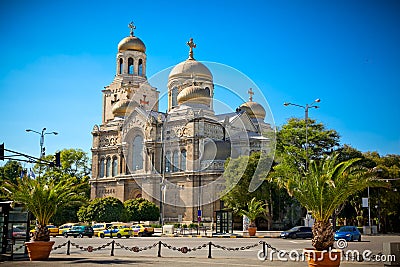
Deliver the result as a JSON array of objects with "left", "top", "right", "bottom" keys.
[{"left": 124, "top": 198, "right": 160, "bottom": 222}]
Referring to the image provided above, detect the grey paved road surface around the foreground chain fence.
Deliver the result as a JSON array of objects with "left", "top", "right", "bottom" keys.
[{"left": 0, "top": 236, "right": 400, "bottom": 267}]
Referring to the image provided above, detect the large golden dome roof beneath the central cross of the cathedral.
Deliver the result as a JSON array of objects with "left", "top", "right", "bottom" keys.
[{"left": 168, "top": 59, "right": 213, "bottom": 81}]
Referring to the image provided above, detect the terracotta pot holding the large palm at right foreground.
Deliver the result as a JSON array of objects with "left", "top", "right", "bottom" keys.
[{"left": 304, "top": 248, "right": 342, "bottom": 267}]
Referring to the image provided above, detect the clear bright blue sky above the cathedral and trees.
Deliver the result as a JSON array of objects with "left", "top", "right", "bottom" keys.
[{"left": 0, "top": 0, "right": 400, "bottom": 164}]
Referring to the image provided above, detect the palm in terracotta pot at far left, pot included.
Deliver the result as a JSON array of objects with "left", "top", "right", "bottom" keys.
[{"left": 2, "top": 176, "right": 83, "bottom": 261}]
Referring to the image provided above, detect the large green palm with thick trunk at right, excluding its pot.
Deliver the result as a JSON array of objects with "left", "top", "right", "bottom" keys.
[{"left": 276, "top": 154, "right": 382, "bottom": 251}]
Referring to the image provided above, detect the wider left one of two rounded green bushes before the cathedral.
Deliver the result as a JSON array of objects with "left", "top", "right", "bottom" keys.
[{"left": 78, "top": 197, "right": 127, "bottom": 222}]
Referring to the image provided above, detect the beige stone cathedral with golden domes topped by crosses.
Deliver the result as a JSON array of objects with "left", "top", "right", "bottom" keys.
[{"left": 90, "top": 23, "right": 272, "bottom": 222}]
